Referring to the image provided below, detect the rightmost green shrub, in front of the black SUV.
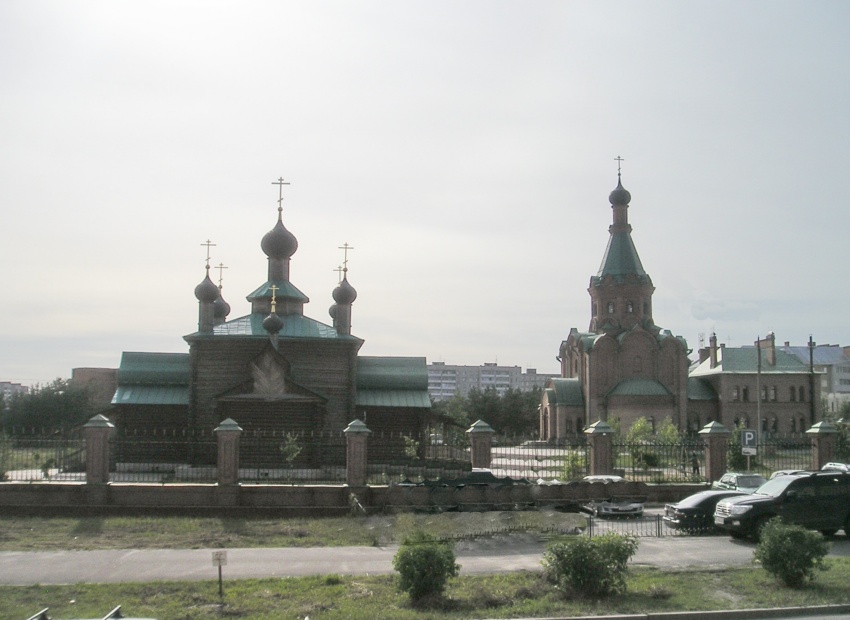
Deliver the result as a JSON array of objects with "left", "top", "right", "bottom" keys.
[{"left": 754, "top": 518, "right": 829, "bottom": 588}]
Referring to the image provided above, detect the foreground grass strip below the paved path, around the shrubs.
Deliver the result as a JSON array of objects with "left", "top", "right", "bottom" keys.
[{"left": 0, "top": 558, "right": 850, "bottom": 620}]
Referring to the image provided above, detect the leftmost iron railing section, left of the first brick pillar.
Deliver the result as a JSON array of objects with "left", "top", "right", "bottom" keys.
[{"left": 0, "top": 428, "right": 86, "bottom": 482}]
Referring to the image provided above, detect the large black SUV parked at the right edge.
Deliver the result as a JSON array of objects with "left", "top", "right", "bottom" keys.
[{"left": 714, "top": 471, "right": 850, "bottom": 538}]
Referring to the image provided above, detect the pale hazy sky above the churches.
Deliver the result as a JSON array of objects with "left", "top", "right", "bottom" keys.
[{"left": 0, "top": 0, "right": 850, "bottom": 385}]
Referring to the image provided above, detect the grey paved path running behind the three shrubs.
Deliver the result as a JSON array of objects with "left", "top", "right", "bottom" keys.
[{"left": 0, "top": 536, "right": 850, "bottom": 585}]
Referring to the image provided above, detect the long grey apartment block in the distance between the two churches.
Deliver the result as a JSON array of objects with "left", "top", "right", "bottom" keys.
[{"left": 428, "top": 362, "right": 558, "bottom": 402}]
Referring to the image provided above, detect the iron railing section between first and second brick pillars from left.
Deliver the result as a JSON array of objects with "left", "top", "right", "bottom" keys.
[{"left": 109, "top": 428, "right": 218, "bottom": 484}]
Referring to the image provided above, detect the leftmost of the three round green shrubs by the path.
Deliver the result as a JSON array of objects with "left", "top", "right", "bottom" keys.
[{"left": 393, "top": 532, "right": 460, "bottom": 601}]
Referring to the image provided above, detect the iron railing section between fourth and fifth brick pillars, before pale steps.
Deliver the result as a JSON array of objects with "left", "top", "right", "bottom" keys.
[{"left": 490, "top": 437, "right": 590, "bottom": 482}]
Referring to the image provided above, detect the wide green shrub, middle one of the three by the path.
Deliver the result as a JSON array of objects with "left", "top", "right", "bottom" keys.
[{"left": 543, "top": 532, "right": 638, "bottom": 598}]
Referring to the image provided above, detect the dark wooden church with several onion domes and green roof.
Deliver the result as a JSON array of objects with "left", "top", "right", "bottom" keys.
[{"left": 112, "top": 179, "right": 431, "bottom": 456}]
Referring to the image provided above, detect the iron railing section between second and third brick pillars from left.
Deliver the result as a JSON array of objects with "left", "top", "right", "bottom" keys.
[{"left": 239, "top": 430, "right": 346, "bottom": 484}]
